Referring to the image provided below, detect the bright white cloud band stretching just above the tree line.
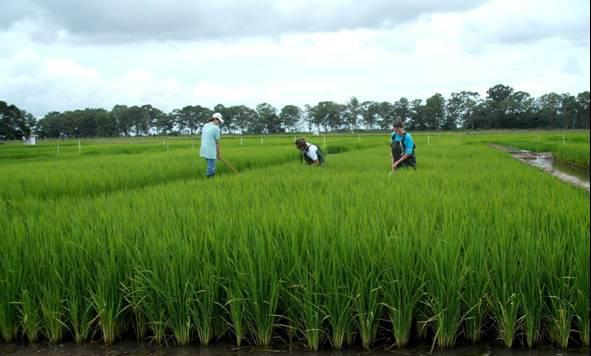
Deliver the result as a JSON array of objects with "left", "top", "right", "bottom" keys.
[{"left": 0, "top": 0, "right": 590, "bottom": 115}]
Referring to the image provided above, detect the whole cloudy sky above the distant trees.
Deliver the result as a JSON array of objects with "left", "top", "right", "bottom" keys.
[{"left": 0, "top": 0, "right": 590, "bottom": 118}]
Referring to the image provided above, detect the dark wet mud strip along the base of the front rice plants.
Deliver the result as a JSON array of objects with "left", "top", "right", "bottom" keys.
[{"left": 0, "top": 341, "right": 589, "bottom": 356}]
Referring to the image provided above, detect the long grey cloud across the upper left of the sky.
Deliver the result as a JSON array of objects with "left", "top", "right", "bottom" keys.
[{"left": 0, "top": 0, "right": 483, "bottom": 43}]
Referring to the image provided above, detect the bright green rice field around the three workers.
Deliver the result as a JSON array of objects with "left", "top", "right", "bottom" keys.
[{"left": 0, "top": 132, "right": 590, "bottom": 350}]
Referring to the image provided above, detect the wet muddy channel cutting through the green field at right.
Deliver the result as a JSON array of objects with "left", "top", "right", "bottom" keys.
[{"left": 490, "top": 144, "right": 590, "bottom": 192}]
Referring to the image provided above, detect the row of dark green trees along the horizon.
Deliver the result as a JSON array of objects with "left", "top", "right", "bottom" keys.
[{"left": 0, "top": 84, "right": 589, "bottom": 139}]
